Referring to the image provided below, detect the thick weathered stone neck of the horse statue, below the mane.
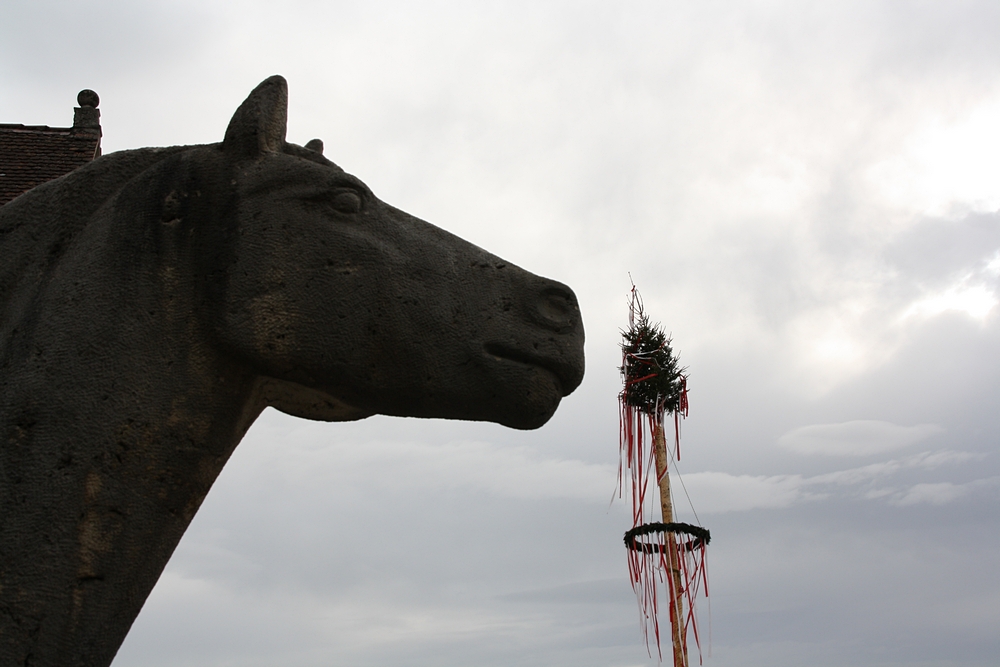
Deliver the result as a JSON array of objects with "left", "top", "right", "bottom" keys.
[{"left": 0, "top": 145, "right": 272, "bottom": 665}]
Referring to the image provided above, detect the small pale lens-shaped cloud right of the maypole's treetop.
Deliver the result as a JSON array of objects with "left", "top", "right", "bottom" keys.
[{"left": 778, "top": 420, "right": 942, "bottom": 456}]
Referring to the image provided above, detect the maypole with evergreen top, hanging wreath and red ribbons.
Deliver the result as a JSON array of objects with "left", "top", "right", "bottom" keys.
[{"left": 618, "top": 285, "right": 711, "bottom": 667}]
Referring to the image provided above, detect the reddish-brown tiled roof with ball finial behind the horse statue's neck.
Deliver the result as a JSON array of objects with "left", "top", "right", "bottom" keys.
[{"left": 0, "top": 90, "right": 101, "bottom": 205}]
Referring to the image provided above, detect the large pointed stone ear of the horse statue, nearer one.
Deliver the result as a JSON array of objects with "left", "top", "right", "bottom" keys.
[{"left": 222, "top": 76, "right": 288, "bottom": 157}]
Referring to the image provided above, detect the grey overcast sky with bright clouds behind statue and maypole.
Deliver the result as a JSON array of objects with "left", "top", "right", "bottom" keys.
[{"left": 0, "top": 0, "right": 1000, "bottom": 667}]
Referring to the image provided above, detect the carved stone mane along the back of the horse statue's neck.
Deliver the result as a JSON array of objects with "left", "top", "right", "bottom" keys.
[{"left": 0, "top": 146, "right": 196, "bottom": 331}]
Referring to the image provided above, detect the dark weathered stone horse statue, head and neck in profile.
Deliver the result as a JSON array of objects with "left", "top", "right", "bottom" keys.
[{"left": 0, "top": 77, "right": 583, "bottom": 667}]
